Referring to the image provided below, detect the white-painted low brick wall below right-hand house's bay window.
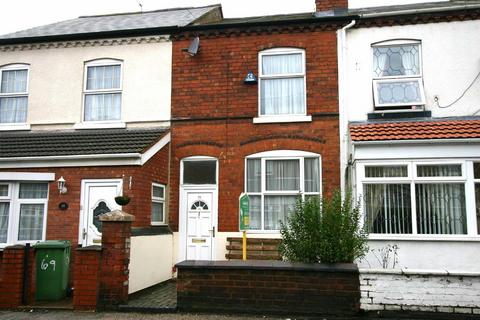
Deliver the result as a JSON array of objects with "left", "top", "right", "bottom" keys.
[{"left": 360, "top": 269, "right": 480, "bottom": 314}]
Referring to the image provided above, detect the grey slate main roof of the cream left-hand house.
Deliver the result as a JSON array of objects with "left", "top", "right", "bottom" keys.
[{"left": 0, "top": 5, "right": 220, "bottom": 40}]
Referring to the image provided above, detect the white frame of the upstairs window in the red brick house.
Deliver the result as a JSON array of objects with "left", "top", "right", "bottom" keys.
[{"left": 253, "top": 48, "right": 312, "bottom": 123}]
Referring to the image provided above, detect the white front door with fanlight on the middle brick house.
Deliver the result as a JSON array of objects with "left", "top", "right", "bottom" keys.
[{"left": 186, "top": 191, "right": 215, "bottom": 260}]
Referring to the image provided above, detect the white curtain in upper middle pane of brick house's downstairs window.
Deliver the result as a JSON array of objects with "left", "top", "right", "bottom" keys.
[{"left": 266, "top": 160, "right": 300, "bottom": 191}]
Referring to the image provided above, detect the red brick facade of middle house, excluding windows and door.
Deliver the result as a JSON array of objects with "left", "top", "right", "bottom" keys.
[{"left": 169, "top": 27, "right": 340, "bottom": 231}]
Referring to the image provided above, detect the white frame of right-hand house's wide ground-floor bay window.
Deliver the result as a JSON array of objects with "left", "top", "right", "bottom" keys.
[{"left": 356, "top": 159, "right": 480, "bottom": 241}]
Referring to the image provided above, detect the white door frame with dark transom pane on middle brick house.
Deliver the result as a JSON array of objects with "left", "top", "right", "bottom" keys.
[{"left": 178, "top": 156, "right": 218, "bottom": 262}]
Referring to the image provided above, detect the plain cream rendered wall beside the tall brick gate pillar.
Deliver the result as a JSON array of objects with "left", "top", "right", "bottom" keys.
[{"left": 128, "top": 229, "right": 173, "bottom": 294}]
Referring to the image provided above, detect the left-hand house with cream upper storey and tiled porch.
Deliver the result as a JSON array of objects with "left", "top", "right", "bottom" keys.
[{"left": 0, "top": 5, "right": 222, "bottom": 296}]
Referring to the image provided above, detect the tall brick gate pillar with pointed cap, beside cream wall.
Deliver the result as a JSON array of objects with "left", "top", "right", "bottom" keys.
[{"left": 99, "top": 210, "right": 135, "bottom": 307}]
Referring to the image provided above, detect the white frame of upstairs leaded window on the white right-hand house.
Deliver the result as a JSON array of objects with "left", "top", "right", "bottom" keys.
[{"left": 371, "top": 40, "right": 426, "bottom": 112}]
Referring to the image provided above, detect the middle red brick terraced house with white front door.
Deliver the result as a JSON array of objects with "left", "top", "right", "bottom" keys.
[{"left": 169, "top": 1, "right": 350, "bottom": 261}]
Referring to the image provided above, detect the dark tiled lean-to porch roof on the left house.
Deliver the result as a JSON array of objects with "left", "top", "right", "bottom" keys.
[{"left": 0, "top": 128, "right": 168, "bottom": 158}]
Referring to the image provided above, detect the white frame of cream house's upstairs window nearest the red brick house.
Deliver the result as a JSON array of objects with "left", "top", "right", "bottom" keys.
[{"left": 74, "top": 59, "right": 126, "bottom": 129}]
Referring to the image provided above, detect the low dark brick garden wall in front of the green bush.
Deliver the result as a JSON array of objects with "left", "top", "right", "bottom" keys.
[{"left": 177, "top": 261, "right": 360, "bottom": 315}]
